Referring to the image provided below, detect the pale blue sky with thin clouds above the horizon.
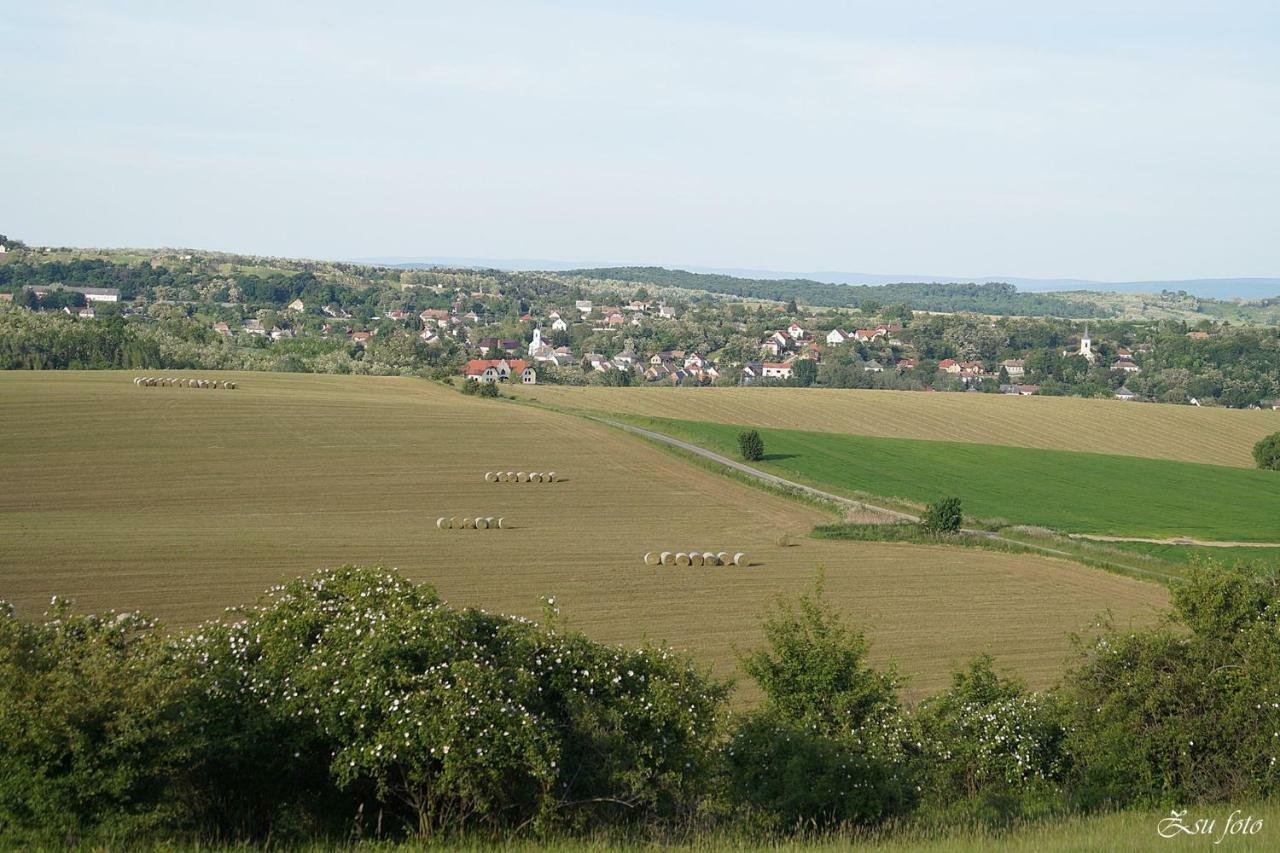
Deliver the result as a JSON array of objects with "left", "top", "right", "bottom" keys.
[{"left": 0, "top": 0, "right": 1280, "bottom": 279}]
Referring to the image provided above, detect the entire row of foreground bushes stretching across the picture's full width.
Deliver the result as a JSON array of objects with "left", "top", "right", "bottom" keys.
[{"left": 0, "top": 567, "right": 1280, "bottom": 844}]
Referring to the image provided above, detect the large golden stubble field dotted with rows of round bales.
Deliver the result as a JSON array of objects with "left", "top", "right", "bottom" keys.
[{"left": 0, "top": 371, "right": 1166, "bottom": 693}]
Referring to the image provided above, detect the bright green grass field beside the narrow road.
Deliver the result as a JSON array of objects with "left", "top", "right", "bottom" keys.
[{"left": 606, "top": 418, "right": 1280, "bottom": 542}]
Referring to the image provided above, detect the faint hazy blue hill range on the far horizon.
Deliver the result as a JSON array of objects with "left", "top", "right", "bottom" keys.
[{"left": 355, "top": 257, "right": 1280, "bottom": 300}]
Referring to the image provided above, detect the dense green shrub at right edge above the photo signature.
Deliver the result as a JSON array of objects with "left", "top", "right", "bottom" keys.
[{"left": 1066, "top": 566, "right": 1280, "bottom": 808}]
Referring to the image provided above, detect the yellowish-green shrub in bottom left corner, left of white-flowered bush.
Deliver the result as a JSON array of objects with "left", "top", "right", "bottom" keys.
[{"left": 0, "top": 598, "right": 200, "bottom": 845}]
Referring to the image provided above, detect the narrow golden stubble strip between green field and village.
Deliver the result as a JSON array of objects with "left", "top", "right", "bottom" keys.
[{"left": 513, "top": 386, "right": 1280, "bottom": 467}]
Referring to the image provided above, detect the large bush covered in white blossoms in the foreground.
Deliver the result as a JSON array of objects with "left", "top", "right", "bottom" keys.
[{"left": 175, "top": 567, "right": 724, "bottom": 835}]
